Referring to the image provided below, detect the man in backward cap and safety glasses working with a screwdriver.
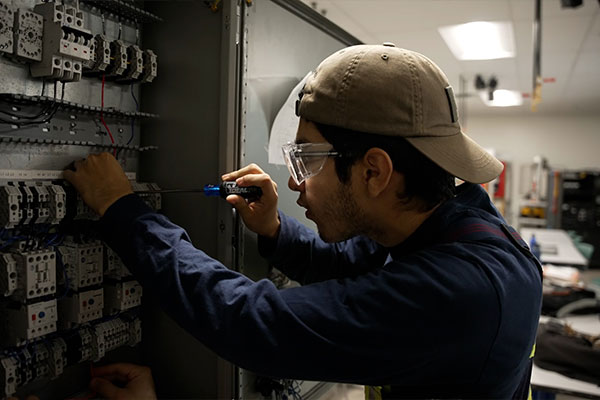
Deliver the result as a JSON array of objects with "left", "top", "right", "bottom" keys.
[{"left": 65, "top": 43, "right": 541, "bottom": 398}]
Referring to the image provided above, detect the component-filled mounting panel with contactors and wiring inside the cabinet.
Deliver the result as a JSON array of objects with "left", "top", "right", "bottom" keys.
[{"left": 0, "top": 0, "right": 161, "bottom": 398}]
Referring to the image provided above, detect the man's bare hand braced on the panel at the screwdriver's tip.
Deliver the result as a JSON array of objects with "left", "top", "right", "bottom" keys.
[{"left": 63, "top": 153, "right": 133, "bottom": 216}]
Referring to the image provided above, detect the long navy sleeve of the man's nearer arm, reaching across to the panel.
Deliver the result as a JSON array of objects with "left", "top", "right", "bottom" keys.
[{"left": 101, "top": 195, "right": 497, "bottom": 384}]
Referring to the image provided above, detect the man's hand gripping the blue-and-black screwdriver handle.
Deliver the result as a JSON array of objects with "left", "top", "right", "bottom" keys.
[{"left": 221, "top": 164, "right": 281, "bottom": 239}]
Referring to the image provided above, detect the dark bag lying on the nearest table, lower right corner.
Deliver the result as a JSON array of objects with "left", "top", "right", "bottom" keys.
[{"left": 533, "top": 321, "right": 600, "bottom": 385}]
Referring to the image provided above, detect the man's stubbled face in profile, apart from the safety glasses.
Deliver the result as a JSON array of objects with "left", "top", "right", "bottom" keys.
[{"left": 288, "top": 118, "right": 366, "bottom": 242}]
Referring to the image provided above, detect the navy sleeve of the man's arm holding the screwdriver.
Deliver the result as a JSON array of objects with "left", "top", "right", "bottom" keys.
[{"left": 258, "top": 211, "right": 389, "bottom": 285}]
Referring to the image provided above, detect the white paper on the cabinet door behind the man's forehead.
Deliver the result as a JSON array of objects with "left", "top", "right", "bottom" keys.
[{"left": 269, "top": 72, "right": 312, "bottom": 165}]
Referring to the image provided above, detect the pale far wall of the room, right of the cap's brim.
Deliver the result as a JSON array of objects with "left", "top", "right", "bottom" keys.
[{"left": 465, "top": 113, "right": 600, "bottom": 224}]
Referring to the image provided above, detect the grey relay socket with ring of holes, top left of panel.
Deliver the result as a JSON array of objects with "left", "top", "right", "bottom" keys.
[{"left": 14, "top": 8, "right": 44, "bottom": 61}]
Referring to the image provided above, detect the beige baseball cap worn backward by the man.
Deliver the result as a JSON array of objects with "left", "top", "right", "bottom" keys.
[{"left": 298, "top": 43, "right": 503, "bottom": 183}]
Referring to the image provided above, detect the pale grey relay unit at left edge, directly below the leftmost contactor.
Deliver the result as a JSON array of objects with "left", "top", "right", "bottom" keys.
[{"left": 3, "top": 299, "right": 57, "bottom": 346}]
